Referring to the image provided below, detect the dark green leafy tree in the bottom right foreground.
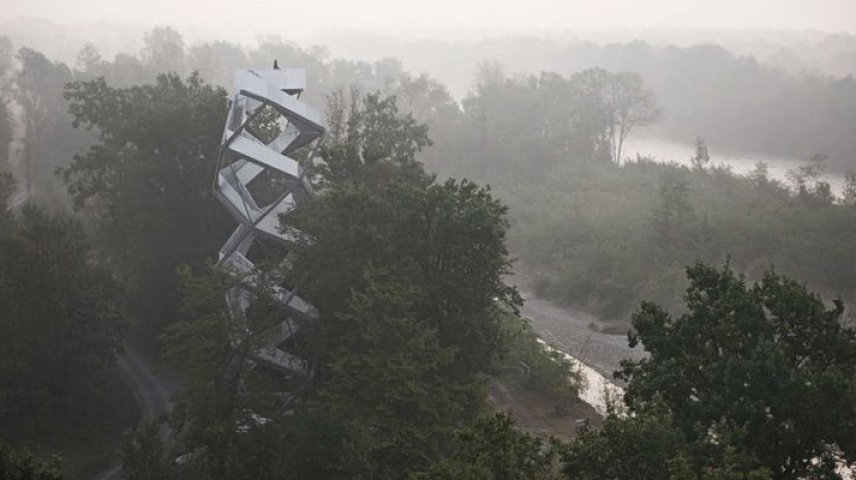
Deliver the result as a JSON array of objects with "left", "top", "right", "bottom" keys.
[{"left": 568, "top": 264, "right": 856, "bottom": 479}]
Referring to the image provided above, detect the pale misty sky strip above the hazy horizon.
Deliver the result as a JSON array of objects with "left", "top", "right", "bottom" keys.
[{"left": 0, "top": 0, "right": 856, "bottom": 34}]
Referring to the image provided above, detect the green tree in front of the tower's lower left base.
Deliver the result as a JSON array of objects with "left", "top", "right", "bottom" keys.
[{"left": 160, "top": 267, "right": 304, "bottom": 479}]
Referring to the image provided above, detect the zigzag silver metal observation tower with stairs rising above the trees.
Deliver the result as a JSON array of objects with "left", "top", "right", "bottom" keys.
[{"left": 214, "top": 68, "right": 325, "bottom": 377}]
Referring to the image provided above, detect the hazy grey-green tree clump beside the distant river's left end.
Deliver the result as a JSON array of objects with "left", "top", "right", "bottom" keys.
[{"left": 446, "top": 66, "right": 658, "bottom": 179}]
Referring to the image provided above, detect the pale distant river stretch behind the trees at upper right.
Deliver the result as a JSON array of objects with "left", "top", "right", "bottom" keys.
[{"left": 622, "top": 135, "right": 844, "bottom": 196}]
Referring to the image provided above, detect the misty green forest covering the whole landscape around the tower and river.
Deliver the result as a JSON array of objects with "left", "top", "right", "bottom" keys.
[{"left": 0, "top": 16, "right": 856, "bottom": 480}]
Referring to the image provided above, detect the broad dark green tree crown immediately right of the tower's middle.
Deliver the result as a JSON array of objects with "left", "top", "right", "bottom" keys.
[{"left": 294, "top": 176, "right": 519, "bottom": 374}]
